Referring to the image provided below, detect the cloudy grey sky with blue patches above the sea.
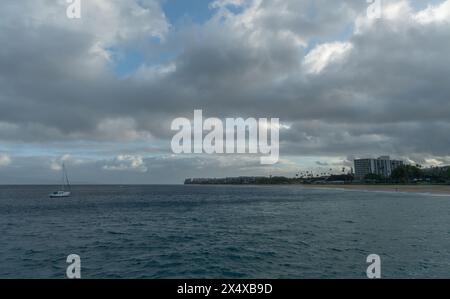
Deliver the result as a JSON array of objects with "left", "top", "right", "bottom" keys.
[{"left": 0, "top": 0, "right": 450, "bottom": 184}]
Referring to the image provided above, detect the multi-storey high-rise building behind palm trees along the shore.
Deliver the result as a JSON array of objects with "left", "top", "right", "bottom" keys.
[{"left": 355, "top": 156, "right": 404, "bottom": 180}]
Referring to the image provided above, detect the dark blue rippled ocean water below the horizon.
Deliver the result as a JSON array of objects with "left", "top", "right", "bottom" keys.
[{"left": 0, "top": 186, "right": 450, "bottom": 278}]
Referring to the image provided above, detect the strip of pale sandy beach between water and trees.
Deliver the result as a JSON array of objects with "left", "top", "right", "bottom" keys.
[{"left": 303, "top": 185, "right": 450, "bottom": 196}]
